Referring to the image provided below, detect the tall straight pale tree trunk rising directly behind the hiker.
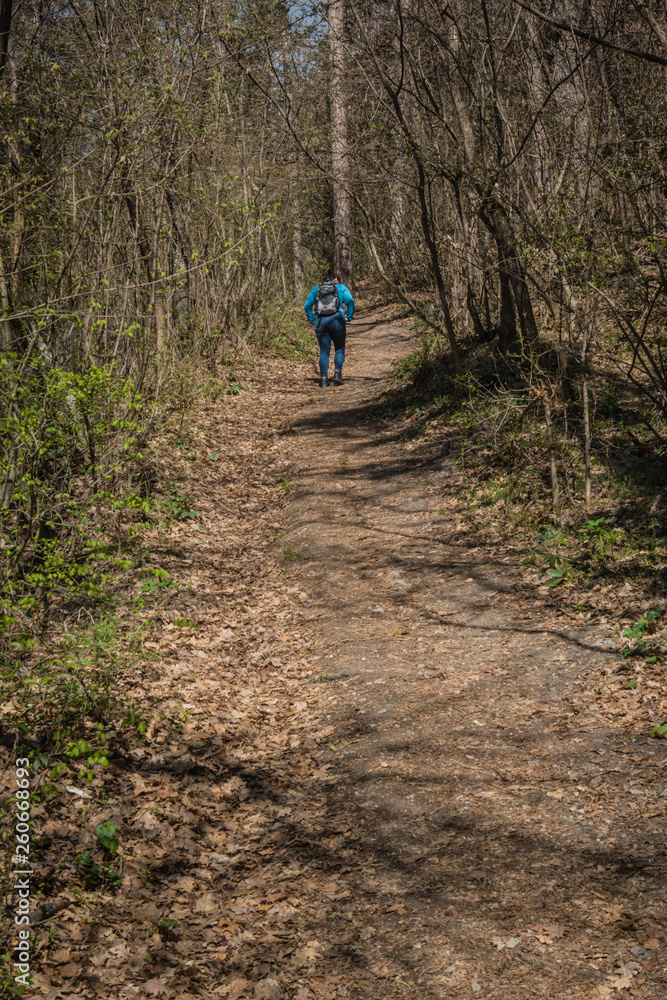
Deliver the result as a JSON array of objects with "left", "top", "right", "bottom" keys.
[{"left": 329, "top": 0, "right": 352, "bottom": 286}]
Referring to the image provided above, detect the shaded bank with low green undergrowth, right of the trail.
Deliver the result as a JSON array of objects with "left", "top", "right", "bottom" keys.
[{"left": 380, "top": 324, "right": 667, "bottom": 613}]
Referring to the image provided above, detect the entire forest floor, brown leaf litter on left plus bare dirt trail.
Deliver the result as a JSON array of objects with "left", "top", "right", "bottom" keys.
[{"left": 10, "top": 313, "right": 667, "bottom": 1000}]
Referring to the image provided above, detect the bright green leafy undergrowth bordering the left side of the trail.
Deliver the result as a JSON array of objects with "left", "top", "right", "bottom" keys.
[{"left": 0, "top": 358, "right": 247, "bottom": 756}]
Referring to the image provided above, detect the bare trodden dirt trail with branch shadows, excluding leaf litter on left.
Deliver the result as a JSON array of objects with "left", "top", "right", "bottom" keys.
[{"left": 276, "top": 308, "right": 667, "bottom": 1000}]
